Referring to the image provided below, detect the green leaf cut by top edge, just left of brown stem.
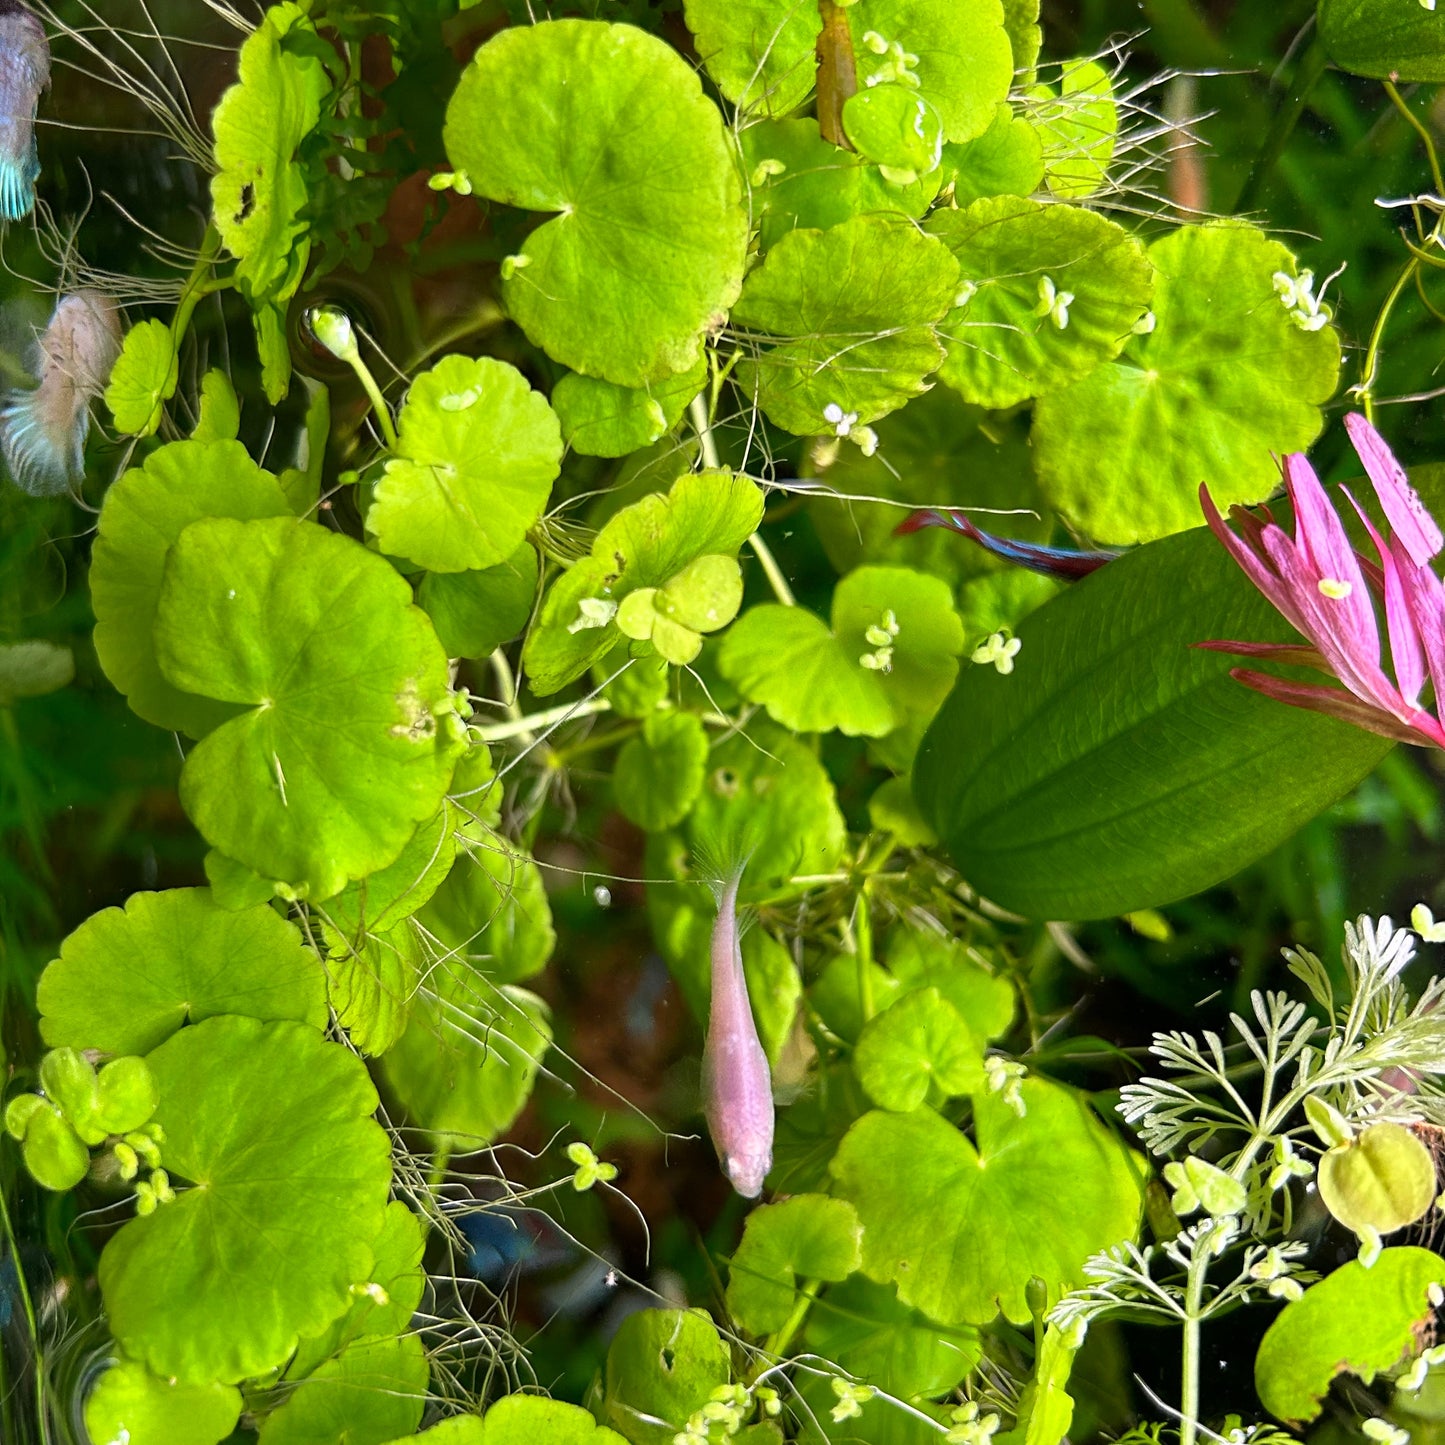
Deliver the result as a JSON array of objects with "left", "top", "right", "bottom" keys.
[{"left": 682, "top": 0, "right": 822, "bottom": 117}]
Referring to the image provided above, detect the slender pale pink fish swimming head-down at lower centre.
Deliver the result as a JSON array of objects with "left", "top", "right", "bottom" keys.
[{"left": 702, "top": 864, "right": 773, "bottom": 1199}]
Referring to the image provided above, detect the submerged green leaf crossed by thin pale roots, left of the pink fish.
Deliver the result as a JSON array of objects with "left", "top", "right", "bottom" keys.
[{"left": 381, "top": 976, "right": 552, "bottom": 1149}]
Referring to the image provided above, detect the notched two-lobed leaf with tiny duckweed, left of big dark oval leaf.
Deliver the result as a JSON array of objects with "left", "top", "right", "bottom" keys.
[{"left": 718, "top": 566, "right": 964, "bottom": 737}]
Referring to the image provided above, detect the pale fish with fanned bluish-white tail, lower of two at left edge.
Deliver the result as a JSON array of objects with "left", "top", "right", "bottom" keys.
[{"left": 0, "top": 287, "right": 121, "bottom": 497}]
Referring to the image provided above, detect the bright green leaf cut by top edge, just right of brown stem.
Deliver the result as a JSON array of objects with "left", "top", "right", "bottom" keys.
[{"left": 845, "top": 0, "right": 1013, "bottom": 140}]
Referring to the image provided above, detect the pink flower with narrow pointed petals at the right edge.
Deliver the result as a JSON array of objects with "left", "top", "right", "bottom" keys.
[{"left": 1195, "top": 413, "right": 1445, "bottom": 747}]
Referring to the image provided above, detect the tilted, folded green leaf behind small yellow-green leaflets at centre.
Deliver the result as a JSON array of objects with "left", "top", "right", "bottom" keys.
[{"left": 522, "top": 471, "right": 763, "bottom": 695}]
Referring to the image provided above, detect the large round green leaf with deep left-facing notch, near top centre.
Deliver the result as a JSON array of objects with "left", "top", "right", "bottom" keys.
[{"left": 445, "top": 20, "right": 749, "bottom": 386}]
